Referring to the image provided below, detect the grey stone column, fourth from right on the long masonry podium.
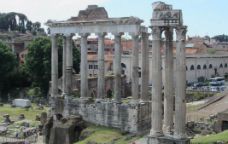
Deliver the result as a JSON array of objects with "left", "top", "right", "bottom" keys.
[{"left": 97, "top": 33, "right": 106, "bottom": 99}]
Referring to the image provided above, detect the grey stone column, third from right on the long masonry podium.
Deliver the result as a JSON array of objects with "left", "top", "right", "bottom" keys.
[{"left": 114, "top": 33, "right": 122, "bottom": 103}]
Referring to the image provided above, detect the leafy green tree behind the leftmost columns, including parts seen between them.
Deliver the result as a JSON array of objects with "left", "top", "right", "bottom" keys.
[{"left": 25, "top": 37, "right": 80, "bottom": 96}]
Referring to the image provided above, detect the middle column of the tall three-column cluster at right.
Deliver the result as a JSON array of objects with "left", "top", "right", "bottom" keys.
[{"left": 163, "top": 28, "right": 174, "bottom": 135}]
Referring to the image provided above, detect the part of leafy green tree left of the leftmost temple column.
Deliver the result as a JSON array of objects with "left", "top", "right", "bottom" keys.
[{"left": 25, "top": 37, "right": 51, "bottom": 94}]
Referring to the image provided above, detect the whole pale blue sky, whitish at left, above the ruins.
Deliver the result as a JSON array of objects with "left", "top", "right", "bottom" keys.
[{"left": 0, "top": 0, "right": 228, "bottom": 36}]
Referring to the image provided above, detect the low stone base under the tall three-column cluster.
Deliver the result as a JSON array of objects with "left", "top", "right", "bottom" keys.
[{"left": 147, "top": 136, "right": 190, "bottom": 144}]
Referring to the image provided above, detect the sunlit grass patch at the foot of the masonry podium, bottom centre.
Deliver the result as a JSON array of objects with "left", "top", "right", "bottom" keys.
[{"left": 75, "top": 125, "right": 140, "bottom": 144}]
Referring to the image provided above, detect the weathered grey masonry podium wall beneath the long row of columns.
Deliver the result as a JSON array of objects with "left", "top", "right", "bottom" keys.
[{"left": 66, "top": 99, "right": 151, "bottom": 134}]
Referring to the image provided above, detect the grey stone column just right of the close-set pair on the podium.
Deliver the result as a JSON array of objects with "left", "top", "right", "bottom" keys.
[{"left": 80, "top": 33, "right": 89, "bottom": 98}]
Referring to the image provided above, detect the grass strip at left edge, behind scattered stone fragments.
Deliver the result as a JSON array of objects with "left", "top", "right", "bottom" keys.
[{"left": 0, "top": 104, "right": 47, "bottom": 122}]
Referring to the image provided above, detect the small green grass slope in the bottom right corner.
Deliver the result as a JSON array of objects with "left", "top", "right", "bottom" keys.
[{"left": 191, "top": 131, "right": 228, "bottom": 144}]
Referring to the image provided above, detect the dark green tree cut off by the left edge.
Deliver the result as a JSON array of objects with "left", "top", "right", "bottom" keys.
[{"left": 0, "top": 41, "right": 17, "bottom": 98}]
